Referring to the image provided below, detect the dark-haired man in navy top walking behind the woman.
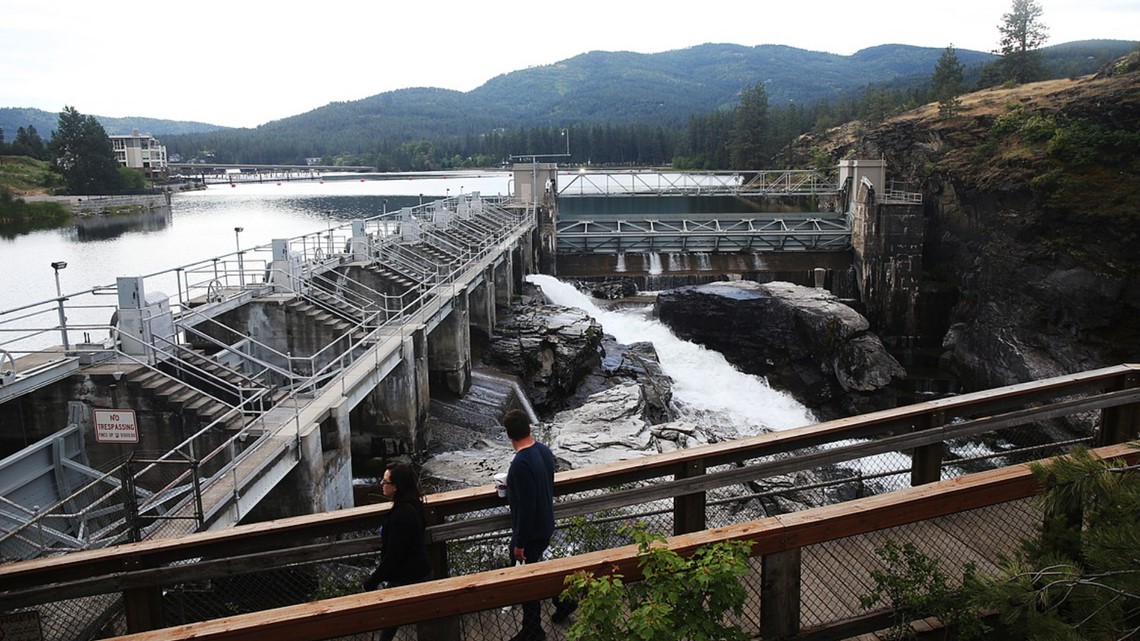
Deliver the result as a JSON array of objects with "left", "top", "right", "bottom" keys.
[{"left": 503, "top": 409, "right": 578, "bottom": 641}]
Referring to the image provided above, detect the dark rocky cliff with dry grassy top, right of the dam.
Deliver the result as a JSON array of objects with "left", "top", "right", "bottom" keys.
[{"left": 787, "top": 57, "right": 1140, "bottom": 389}]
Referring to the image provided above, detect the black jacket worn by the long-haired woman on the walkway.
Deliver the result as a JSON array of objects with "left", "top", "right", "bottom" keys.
[{"left": 364, "top": 503, "right": 431, "bottom": 590}]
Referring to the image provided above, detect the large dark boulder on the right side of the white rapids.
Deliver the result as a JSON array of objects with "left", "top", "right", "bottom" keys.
[{"left": 654, "top": 281, "right": 906, "bottom": 419}]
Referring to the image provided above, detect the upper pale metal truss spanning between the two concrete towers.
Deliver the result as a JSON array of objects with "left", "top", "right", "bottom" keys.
[{"left": 557, "top": 170, "right": 839, "bottom": 198}]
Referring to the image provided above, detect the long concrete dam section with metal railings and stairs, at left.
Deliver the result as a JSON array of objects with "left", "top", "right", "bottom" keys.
[{"left": 0, "top": 194, "right": 535, "bottom": 560}]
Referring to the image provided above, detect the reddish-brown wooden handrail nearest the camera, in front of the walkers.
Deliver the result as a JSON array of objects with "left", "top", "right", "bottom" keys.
[{"left": 102, "top": 445, "right": 1140, "bottom": 641}]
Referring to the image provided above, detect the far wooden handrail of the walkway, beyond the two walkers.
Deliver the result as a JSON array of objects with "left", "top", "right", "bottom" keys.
[{"left": 0, "top": 365, "right": 1140, "bottom": 608}]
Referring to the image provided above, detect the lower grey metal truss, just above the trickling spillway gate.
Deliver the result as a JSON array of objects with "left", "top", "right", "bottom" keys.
[{"left": 557, "top": 212, "right": 852, "bottom": 254}]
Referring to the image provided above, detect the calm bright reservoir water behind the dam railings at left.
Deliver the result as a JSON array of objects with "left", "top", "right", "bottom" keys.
[{"left": 0, "top": 171, "right": 511, "bottom": 309}]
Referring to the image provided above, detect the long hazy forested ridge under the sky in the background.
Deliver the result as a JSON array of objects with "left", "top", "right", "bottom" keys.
[{"left": 0, "top": 40, "right": 1133, "bottom": 163}]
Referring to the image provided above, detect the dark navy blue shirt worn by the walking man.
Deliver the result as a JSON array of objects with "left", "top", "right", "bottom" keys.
[{"left": 506, "top": 440, "right": 554, "bottom": 547}]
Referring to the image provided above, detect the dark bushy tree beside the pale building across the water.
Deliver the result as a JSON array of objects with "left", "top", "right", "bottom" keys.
[{"left": 49, "top": 106, "right": 120, "bottom": 194}]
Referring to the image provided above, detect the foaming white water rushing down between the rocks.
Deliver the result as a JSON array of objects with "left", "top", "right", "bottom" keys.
[{"left": 527, "top": 275, "right": 816, "bottom": 436}]
